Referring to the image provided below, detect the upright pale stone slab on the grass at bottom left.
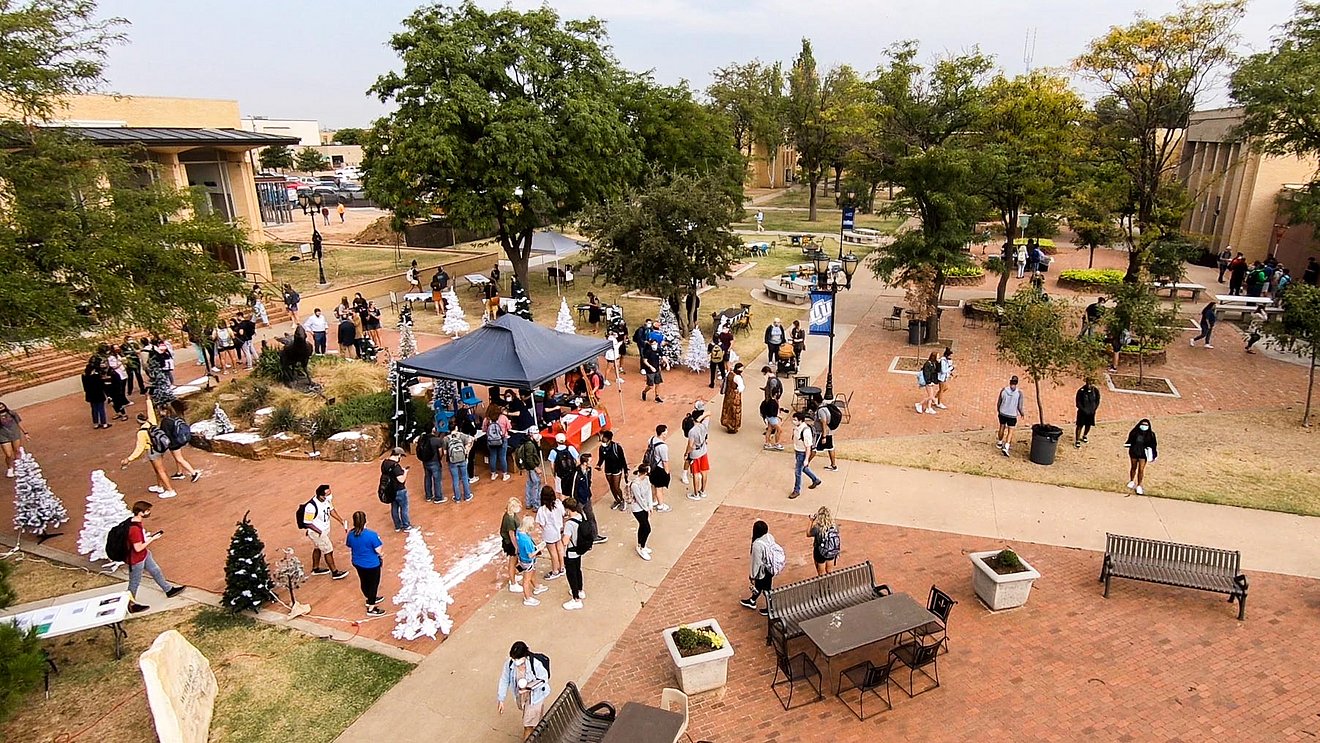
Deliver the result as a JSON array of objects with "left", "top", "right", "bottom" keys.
[{"left": 137, "top": 630, "right": 219, "bottom": 743}]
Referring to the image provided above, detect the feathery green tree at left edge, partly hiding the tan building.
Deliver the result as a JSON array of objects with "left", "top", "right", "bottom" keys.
[{"left": 0, "top": 0, "right": 246, "bottom": 361}]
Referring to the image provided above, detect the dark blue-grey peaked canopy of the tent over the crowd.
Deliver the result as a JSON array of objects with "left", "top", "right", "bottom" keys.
[{"left": 395, "top": 314, "right": 610, "bottom": 441}]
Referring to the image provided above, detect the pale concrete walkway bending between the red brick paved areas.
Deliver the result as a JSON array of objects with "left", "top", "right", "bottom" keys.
[{"left": 339, "top": 326, "right": 1320, "bottom": 742}]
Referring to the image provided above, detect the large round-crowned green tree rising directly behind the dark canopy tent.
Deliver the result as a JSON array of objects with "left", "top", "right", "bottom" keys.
[{"left": 364, "top": 1, "right": 643, "bottom": 285}]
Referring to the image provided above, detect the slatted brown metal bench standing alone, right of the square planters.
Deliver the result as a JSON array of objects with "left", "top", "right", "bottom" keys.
[{"left": 1100, "top": 534, "right": 1247, "bottom": 622}]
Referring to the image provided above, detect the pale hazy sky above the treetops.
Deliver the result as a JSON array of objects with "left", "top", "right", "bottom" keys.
[{"left": 100, "top": 0, "right": 1292, "bottom": 128}]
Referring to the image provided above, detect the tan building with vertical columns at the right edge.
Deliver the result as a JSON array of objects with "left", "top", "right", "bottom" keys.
[{"left": 1179, "top": 108, "right": 1317, "bottom": 268}]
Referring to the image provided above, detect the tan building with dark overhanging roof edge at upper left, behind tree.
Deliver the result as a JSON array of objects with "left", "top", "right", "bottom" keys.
[{"left": 32, "top": 95, "right": 297, "bottom": 281}]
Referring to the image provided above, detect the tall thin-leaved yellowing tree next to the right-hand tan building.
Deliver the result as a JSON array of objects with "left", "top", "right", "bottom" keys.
[{"left": 1073, "top": 0, "right": 1246, "bottom": 282}]
